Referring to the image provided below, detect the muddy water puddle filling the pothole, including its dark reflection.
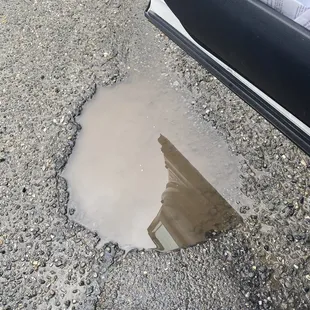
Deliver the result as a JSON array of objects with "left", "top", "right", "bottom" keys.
[{"left": 64, "top": 79, "right": 246, "bottom": 250}]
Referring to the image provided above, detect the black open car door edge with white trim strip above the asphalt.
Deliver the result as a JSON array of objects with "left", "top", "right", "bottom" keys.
[{"left": 146, "top": 0, "right": 310, "bottom": 155}]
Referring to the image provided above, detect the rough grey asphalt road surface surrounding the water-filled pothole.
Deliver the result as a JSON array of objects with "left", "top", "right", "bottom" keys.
[{"left": 0, "top": 0, "right": 310, "bottom": 310}]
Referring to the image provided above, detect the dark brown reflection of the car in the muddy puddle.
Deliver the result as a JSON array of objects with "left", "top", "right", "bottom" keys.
[{"left": 148, "top": 135, "right": 242, "bottom": 250}]
